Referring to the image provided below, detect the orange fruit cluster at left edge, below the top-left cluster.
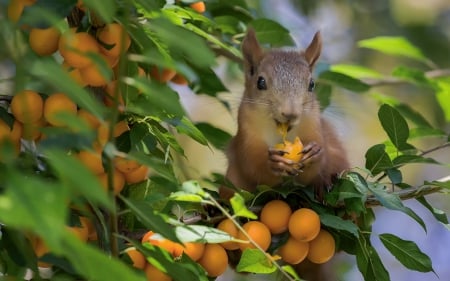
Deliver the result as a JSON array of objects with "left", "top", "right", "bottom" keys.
[{"left": 0, "top": 90, "right": 148, "bottom": 194}]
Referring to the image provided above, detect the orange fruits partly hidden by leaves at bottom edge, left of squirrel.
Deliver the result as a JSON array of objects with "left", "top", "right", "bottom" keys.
[{"left": 118, "top": 231, "right": 228, "bottom": 281}]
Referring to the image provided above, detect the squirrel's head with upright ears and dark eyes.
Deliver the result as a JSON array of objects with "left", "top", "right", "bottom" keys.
[{"left": 242, "top": 29, "right": 322, "bottom": 127}]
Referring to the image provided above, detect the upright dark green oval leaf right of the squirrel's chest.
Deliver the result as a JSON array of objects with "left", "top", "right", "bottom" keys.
[{"left": 378, "top": 104, "right": 409, "bottom": 150}]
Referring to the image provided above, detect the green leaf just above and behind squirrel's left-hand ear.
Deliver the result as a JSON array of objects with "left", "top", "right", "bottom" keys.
[{"left": 248, "top": 19, "right": 294, "bottom": 47}]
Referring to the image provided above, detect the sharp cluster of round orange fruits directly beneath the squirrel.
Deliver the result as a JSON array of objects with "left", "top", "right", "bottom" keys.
[{"left": 217, "top": 200, "right": 335, "bottom": 264}]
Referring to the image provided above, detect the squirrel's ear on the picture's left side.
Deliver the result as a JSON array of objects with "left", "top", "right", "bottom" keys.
[{"left": 242, "top": 28, "right": 263, "bottom": 75}]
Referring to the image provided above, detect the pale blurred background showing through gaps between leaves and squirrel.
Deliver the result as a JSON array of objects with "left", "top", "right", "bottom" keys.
[{"left": 174, "top": 0, "right": 450, "bottom": 281}]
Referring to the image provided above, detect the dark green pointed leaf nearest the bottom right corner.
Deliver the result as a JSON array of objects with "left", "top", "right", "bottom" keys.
[{"left": 379, "top": 233, "right": 434, "bottom": 272}]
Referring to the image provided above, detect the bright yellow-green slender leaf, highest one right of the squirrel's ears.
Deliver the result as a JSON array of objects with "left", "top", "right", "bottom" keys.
[{"left": 358, "top": 36, "right": 428, "bottom": 62}]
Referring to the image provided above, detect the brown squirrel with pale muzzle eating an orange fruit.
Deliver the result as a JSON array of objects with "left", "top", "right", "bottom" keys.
[{"left": 219, "top": 28, "right": 349, "bottom": 199}]
